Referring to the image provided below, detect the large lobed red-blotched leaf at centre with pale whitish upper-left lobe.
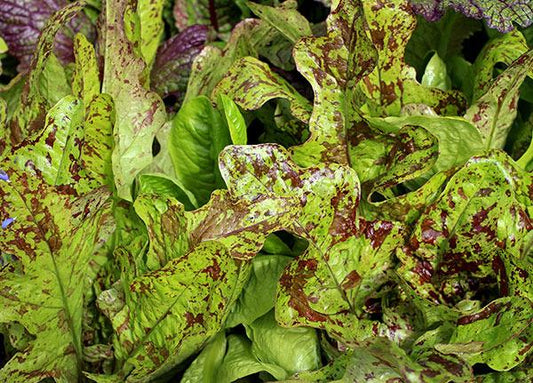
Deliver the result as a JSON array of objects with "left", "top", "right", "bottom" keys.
[{"left": 221, "top": 145, "right": 402, "bottom": 341}]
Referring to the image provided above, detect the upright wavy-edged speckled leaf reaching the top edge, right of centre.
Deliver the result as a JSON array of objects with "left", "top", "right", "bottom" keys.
[{"left": 286, "top": 0, "right": 377, "bottom": 166}]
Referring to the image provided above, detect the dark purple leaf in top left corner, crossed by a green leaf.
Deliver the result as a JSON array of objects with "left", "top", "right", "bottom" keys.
[{"left": 0, "top": 0, "right": 94, "bottom": 72}]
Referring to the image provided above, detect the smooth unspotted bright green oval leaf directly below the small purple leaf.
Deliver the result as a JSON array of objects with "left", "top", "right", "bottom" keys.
[{"left": 168, "top": 96, "right": 231, "bottom": 207}]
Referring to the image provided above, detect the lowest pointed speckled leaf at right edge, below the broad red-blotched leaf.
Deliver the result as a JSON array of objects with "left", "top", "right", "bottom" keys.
[{"left": 436, "top": 296, "right": 533, "bottom": 371}]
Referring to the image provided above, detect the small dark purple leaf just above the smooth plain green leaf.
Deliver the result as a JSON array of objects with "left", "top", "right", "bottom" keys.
[{"left": 151, "top": 25, "right": 209, "bottom": 111}]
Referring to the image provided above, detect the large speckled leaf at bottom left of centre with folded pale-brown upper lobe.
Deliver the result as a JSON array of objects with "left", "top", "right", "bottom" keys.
[{"left": 106, "top": 186, "right": 295, "bottom": 382}]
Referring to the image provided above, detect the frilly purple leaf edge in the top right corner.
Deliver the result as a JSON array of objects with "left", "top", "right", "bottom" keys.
[{"left": 410, "top": 0, "right": 533, "bottom": 32}]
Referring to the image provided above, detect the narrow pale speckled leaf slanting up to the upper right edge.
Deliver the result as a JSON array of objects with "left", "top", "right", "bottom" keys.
[{"left": 465, "top": 50, "right": 533, "bottom": 149}]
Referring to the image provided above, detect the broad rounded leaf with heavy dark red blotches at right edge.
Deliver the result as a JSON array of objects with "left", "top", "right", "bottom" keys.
[{"left": 397, "top": 151, "right": 533, "bottom": 303}]
